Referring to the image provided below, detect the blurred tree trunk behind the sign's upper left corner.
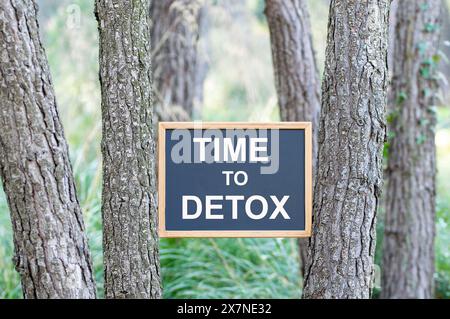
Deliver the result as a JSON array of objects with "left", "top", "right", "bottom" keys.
[{"left": 150, "top": 0, "right": 206, "bottom": 117}]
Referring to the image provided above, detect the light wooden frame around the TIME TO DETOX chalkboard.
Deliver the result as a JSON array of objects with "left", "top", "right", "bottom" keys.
[{"left": 158, "top": 122, "right": 312, "bottom": 238}]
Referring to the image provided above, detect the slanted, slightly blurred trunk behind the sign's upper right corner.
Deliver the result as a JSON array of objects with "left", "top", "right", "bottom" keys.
[{"left": 265, "top": 0, "right": 320, "bottom": 276}]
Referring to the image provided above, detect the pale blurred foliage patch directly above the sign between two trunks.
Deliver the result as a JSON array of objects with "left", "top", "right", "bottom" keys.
[{"left": 201, "top": 0, "right": 278, "bottom": 121}]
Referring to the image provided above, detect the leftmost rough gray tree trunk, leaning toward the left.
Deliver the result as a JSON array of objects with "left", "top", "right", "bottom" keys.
[{"left": 0, "top": 0, "right": 95, "bottom": 298}]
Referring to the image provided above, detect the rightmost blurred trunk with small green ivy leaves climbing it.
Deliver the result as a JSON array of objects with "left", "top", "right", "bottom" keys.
[{"left": 382, "top": 0, "right": 441, "bottom": 298}]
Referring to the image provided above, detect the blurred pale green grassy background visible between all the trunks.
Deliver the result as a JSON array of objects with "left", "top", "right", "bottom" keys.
[{"left": 0, "top": 0, "right": 450, "bottom": 298}]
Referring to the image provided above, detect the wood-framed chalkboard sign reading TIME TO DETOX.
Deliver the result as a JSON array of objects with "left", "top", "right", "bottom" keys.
[{"left": 158, "top": 122, "right": 312, "bottom": 237}]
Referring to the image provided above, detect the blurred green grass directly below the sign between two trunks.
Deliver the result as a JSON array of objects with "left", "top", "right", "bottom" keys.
[{"left": 161, "top": 238, "right": 301, "bottom": 299}]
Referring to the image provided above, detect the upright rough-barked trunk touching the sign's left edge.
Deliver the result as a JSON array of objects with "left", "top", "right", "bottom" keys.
[{"left": 96, "top": 0, "right": 161, "bottom": 298}]
